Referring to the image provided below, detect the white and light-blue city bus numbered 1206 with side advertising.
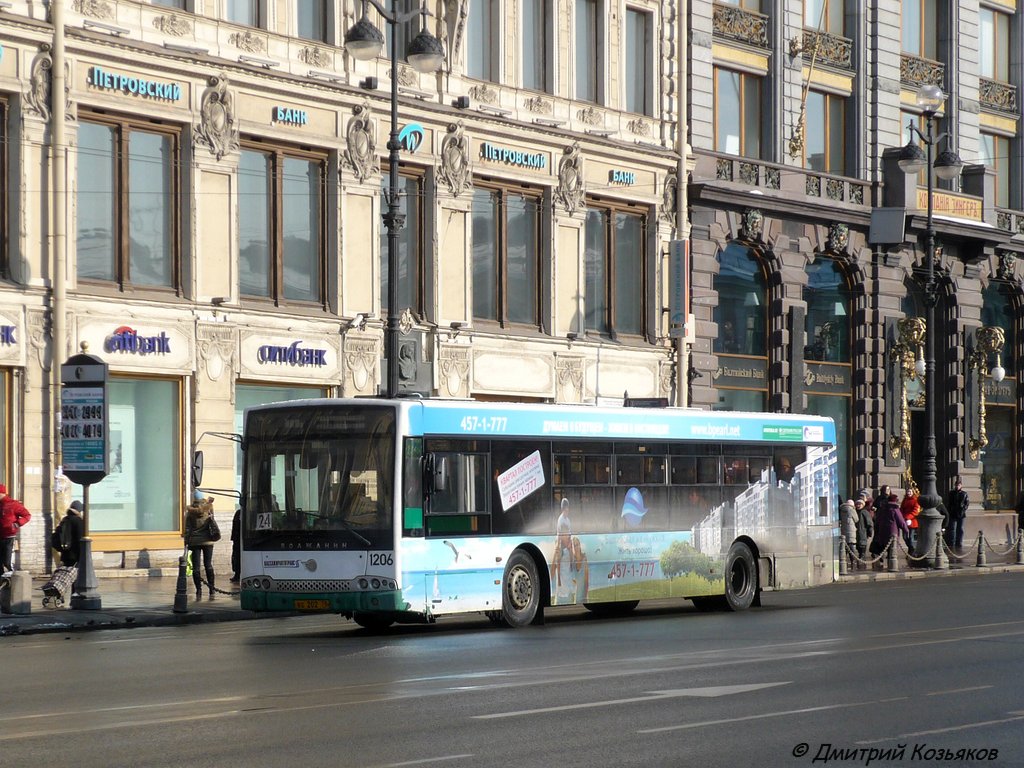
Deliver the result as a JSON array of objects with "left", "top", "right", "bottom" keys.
[{"left": 235, "top": 398, "right": 838, "bottom": 630}]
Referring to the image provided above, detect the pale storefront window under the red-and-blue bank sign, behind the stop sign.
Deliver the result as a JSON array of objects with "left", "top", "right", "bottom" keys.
[{"left": 73, "top": 378, "right": 181, "bottom": 532}]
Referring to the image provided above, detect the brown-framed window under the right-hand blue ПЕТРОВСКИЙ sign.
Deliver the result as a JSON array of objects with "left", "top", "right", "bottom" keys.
[{"left": 472, "top": 182, "right": 542, "bottom": 328}]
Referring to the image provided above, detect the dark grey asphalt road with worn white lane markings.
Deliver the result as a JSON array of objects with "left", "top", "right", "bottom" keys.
[{"left": 0, "top": 573, "right": 1024, "bottom": 768}]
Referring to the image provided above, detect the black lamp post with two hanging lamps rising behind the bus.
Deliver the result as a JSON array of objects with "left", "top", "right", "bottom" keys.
[{"left": 345, "top": 0, "right": 444, "bottom": 398}]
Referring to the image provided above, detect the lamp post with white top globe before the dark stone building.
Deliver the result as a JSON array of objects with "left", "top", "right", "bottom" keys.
[{"left": 899, "top": 85, "right": 964, "bottom": 564}]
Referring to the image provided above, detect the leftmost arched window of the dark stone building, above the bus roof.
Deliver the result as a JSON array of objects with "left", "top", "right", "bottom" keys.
[{"left": 713, "top": 243, "right": 768, "bottom": 412}]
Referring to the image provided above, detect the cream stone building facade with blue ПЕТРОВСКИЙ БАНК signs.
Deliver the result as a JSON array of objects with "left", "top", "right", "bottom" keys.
[{"left": 0, "top": 0, "right": 679, "bottom": 571}]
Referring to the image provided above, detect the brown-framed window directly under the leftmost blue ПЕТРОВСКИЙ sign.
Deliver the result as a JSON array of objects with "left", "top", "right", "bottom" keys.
[{"left": 75, "top": 115, "right": 180, "bottom": 290}]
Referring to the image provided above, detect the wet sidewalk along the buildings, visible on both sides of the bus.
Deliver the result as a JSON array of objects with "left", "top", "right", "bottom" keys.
[{"left": 0, "top": 557, "right": 1024, "bottom": 637}]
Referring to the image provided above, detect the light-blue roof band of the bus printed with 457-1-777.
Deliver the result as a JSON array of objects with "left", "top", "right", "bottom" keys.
[{"left": 249, "top": 397, "right": 836, "bottom": 444}]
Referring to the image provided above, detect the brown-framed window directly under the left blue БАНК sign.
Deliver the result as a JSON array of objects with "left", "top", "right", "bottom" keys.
[{"left": 239, "top": 142, "right": 327, "bottom": 304}]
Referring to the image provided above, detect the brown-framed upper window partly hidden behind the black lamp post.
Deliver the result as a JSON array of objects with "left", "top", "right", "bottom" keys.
[{"left": 380, "top": 168, "right": 426, "bottom": 316}]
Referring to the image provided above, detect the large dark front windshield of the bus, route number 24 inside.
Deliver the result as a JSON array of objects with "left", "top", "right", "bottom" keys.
[{"left": 243, "top": 406, "right": 395, "bottom": 549}]
